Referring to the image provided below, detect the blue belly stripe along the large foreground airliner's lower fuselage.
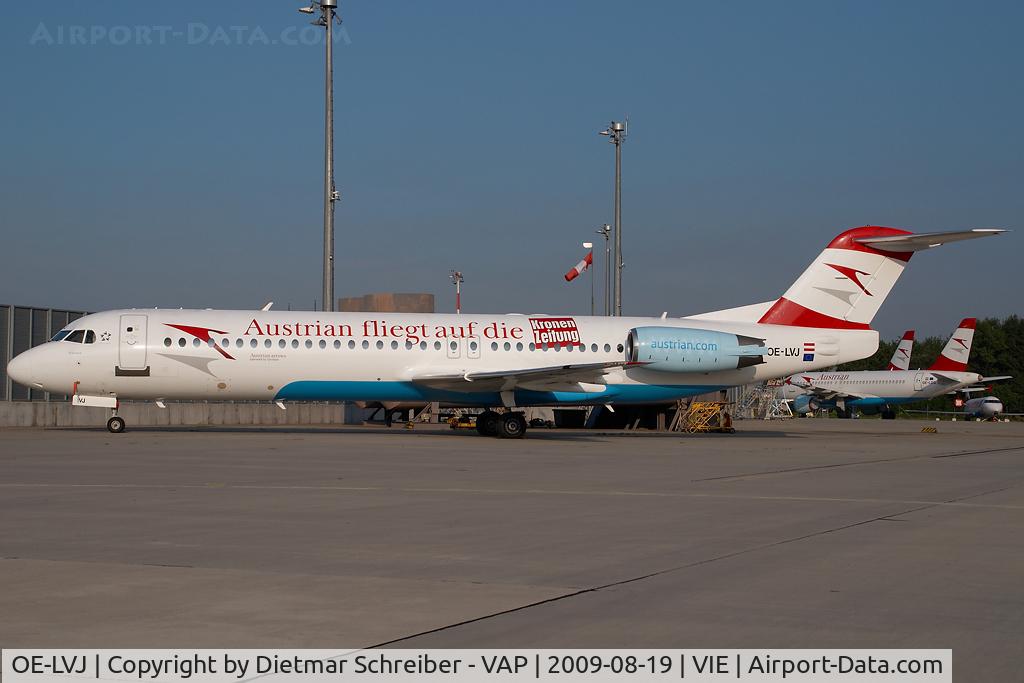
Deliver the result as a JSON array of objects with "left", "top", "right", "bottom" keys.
[{"left": 274, "top": 380, "right": 723, "bottom": 405}]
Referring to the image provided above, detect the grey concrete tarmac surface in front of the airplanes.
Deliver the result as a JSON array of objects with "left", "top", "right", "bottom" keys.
[{"left": 0, "top": 420, "right": 1024, "bottom": 681}]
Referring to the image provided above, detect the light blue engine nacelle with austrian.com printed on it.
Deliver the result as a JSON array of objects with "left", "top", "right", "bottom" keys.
[{"left": 626, "top": 327, "right": 765, "bottom": 373}]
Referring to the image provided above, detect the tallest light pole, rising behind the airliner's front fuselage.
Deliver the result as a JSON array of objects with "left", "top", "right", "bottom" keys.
[{"left": 299, "top": 0, "right": 341, "bottom": 310}]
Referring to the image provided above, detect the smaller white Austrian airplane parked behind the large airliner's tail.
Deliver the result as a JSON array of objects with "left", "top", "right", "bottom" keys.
[{"left": 782, "top": 317, "right": 1007, "bottom": 420}]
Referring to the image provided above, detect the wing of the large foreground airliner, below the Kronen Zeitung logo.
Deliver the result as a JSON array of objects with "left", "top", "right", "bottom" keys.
[{"left": 410, "top": 360, "right": 637, "bottom": 393}]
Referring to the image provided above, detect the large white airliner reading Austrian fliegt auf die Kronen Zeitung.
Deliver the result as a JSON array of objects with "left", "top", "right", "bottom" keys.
[{"left": 7, "top": 226, "right": 1002, "bottom": 438}]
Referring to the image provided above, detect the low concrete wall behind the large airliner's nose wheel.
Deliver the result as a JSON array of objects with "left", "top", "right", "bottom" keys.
[{"left": 0, "top": 401, "right": 368, "bottom": 428}]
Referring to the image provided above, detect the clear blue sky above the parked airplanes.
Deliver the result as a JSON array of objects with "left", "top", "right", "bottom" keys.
[{"left": 0, "top": 0, "right": 1024, "bottom": 337}]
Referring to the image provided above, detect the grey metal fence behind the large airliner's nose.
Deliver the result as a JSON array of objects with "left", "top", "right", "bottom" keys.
[{"left": 0, "top": 304, "right": 87, "bottom": 400}]
